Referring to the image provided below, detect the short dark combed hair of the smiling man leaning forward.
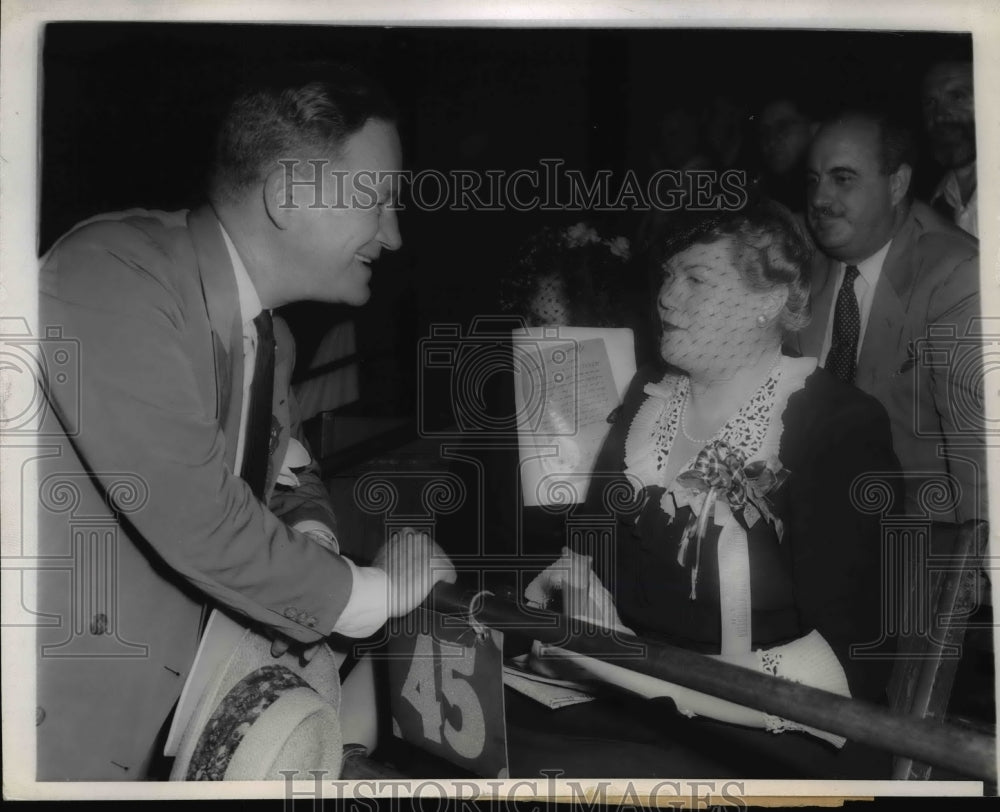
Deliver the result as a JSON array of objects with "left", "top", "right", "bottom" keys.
[{"left": 209, "top": 62, "right": 397, "bottom": 201}]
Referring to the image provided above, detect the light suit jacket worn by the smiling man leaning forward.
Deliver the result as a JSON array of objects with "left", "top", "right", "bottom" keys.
[{"left": 37, "top": 208, "right": 351, "bottom": 781}]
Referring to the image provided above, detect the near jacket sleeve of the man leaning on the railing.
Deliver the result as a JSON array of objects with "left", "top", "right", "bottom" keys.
[{"left": 41, "top": 223, "right": 352, "bottom": 641}]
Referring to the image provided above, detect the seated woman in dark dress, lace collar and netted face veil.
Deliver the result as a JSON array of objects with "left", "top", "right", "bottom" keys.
[{"left": 516, "top": 203, "right": 898, "bottom": 777}]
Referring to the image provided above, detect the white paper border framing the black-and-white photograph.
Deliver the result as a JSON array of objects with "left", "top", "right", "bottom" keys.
[{"left": 0, "top": 0, "right": 1000, "bottom": 804}]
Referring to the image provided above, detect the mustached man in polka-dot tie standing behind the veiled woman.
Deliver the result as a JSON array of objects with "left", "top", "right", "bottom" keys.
[{"left": 799, "top": 113, "right": 987, "bottom": 521}]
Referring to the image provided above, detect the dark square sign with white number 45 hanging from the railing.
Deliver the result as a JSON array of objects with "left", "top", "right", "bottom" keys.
[{"left": 389, "top": 612, "right": 507, "bottom": 778}]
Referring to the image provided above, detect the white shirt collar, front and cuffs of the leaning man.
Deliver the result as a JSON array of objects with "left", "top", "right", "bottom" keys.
[{"left": 219, "top": 223, "right": 389, "bottom": 637}]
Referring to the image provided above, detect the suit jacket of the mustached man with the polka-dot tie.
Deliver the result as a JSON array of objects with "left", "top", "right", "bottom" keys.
[{"left": 799, "top": 201, "right": 987, "bottom": 521}]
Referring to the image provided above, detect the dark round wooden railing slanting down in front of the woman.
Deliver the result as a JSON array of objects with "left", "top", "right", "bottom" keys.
[{"left": 429, "top": 584, "right": 997, "bottom": 782}]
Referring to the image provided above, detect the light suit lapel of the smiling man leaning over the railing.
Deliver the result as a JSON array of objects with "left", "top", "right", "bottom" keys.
[{"left": 188, "top": 206, "right": 243, "bottom": 471}]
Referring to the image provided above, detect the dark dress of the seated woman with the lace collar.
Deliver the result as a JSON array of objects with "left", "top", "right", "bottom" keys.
[{"left": 507, "top": 369, "right": 899, "bottom": 778}]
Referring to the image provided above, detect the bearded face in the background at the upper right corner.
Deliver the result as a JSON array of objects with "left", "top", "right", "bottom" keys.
[{"left": 921, "top": 62, "right": 976, "bottom": 169}]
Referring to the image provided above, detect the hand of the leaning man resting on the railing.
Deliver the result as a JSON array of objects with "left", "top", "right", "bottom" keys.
[{"left": 372, "top": 527, "right": 457, "bottom": 617}]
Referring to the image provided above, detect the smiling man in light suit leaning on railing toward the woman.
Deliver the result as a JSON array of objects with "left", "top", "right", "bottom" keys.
[{"left": 36, "top": 68, "right": 454, "bottom": 781}]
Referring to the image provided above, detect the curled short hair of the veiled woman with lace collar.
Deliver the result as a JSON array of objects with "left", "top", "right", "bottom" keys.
[{"left": 661, "top": 198, "right": 815, "bottom": 333}]
